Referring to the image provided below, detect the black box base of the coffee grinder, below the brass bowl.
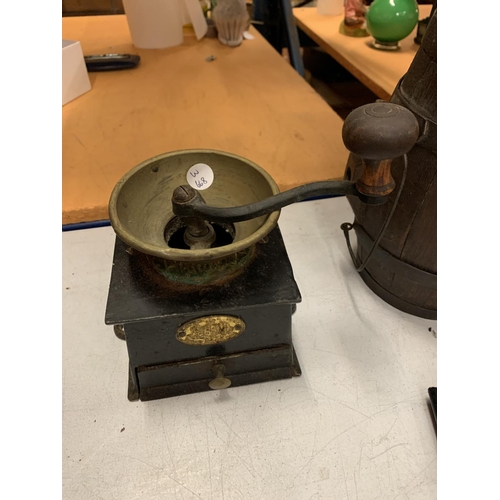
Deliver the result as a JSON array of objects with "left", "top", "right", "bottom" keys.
[{"left": 105, "top": 227, "right": 301, "bottom": 401}]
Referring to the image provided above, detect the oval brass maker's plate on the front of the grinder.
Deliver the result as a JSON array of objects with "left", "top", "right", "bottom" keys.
[{"left": 175, "top": 314, "right": 246, "bottom": 345}]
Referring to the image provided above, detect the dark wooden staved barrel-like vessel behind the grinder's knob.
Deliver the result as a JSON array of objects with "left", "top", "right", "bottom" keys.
[{"left": 345, "top": 11, "right": 437, "bottom": 319}]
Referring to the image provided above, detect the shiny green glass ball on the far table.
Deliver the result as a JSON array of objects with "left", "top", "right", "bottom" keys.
[{"left": 366, "top": 0, "right": 418, "bottom": 44}]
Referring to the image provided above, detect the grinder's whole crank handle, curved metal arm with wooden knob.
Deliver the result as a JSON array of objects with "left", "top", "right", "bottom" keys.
[{"left": 172, "top": 102, "right": 419, "bottom": 225}]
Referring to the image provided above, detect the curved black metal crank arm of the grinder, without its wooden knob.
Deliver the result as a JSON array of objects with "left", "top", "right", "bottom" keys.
[{"left": 172, "top": 181, "right": 360, "bottom": 222}]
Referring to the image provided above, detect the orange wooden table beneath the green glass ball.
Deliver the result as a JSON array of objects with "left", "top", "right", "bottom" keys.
[{"left": 293, "top": 5, "right": 432, "bottom": 100}]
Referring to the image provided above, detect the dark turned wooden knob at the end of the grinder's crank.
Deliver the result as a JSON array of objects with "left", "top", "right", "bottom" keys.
[{"left": 342, "top": 102, "right": 419, "bottom": 196}]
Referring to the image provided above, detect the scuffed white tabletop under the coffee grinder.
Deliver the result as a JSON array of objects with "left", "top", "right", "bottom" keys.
[{"left": 63, "top": 198, "right": 437, "bottom": 500}]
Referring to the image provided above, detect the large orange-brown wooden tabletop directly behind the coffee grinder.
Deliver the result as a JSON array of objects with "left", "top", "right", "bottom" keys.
[{"left": 62, "top": 16, "right": 348, "bottom": 224}]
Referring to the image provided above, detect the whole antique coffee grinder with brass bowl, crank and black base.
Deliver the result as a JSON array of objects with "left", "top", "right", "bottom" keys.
[{"left": 105, "top": 102, "right": 419, "bottom": 401}]
